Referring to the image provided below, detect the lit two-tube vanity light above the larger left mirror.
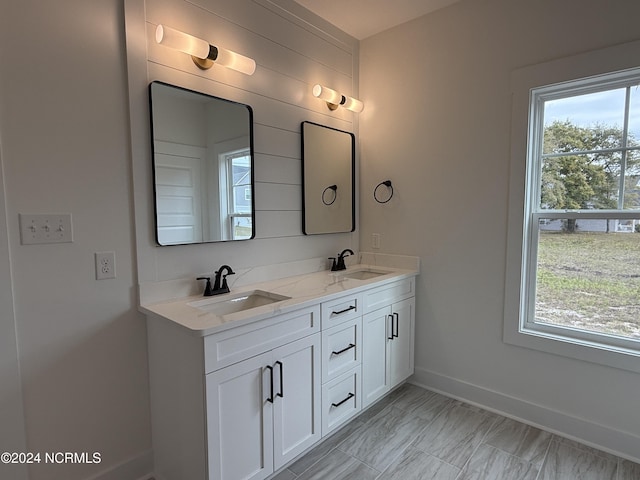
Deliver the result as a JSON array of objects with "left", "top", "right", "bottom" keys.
[{"left": 156, "top": 25, "right": 256, "bottom": 75}]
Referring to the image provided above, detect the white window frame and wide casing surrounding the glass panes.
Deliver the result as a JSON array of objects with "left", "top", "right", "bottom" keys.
[{"left": 503, "top": 42, "right": 640, "bottom": 372}]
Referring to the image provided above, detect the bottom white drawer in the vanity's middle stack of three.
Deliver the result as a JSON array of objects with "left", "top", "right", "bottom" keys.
[{"left": 322, "top": 366, "right": 361, "bottom": 436}]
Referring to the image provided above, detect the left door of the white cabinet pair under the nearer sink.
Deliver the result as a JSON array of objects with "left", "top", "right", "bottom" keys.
[{"left": 206, "top": 352, "right": 273, "bottom": 480}]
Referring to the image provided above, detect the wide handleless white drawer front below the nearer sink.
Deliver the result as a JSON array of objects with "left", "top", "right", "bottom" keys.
[{"left": 204, "top": 305, "right": 320, "bottom": 373}]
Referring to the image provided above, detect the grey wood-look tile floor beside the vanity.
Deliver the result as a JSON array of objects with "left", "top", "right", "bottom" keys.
[{"left": 273, "top": 384, "right": 640, "bottom": 480}]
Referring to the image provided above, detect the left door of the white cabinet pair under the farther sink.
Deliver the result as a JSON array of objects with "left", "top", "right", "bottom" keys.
[{"left": 362, "top": 307, "right": 392, "bottom": 408}]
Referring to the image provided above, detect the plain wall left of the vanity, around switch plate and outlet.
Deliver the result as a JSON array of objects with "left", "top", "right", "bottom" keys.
[{"left": 0, "top": 0, "right": 150, "bottom": 480}]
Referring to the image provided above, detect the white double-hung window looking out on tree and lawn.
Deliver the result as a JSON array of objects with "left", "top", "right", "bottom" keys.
[{"left": 519, "top": 69, "right": 640, "bottom": 351}]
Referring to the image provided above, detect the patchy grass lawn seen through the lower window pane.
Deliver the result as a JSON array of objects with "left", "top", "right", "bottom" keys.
[{"left": 536, "top": 232, "right": 640, "bottom": 339}]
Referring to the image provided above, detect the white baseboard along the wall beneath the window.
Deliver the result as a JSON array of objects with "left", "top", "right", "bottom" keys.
[{"left": 409, "top": 367, "right": 640, "bottom": 463}]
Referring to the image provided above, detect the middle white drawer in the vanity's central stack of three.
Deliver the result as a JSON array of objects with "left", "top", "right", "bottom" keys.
[{"left": 322, "top": 317, "right": 362, "bottom": 383}]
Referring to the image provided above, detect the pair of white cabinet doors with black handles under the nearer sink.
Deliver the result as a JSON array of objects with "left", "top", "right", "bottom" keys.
[{"left": 206, "top": 334, "right": 321, "bottom": 480}]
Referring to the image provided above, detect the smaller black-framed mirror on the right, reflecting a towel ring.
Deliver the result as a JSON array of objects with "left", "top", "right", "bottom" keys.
[{"left": 302, "top": 122, "right": 355, "bottom": 235}]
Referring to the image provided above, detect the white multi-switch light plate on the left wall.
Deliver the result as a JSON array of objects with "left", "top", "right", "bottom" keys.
[{"left": 19, "top": 213, "right": 73, "bottom": 245}]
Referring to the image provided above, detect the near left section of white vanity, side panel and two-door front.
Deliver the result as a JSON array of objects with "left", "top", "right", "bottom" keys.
[{"left": 148, "top": 305, "right": 322, "bottom": 480}]
